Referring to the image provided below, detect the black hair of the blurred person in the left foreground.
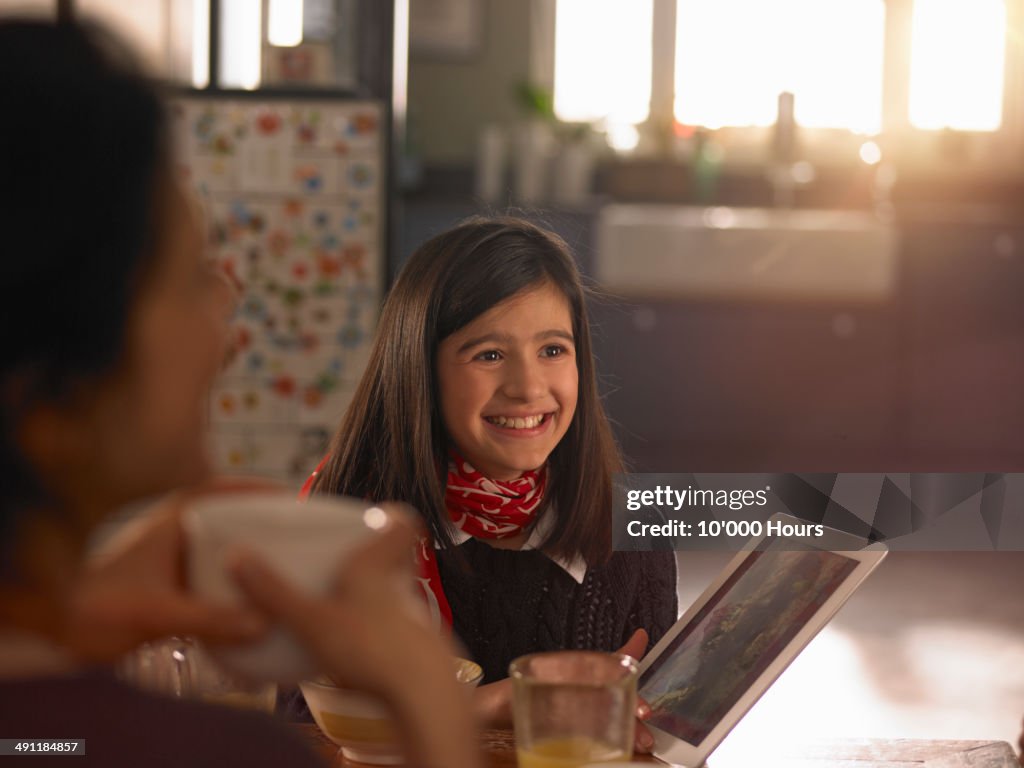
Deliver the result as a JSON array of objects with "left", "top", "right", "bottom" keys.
[{"left": 0, "top": 20, "right": 169, "bottom": 560}]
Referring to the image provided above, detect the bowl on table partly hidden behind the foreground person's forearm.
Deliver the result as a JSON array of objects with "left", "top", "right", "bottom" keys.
[{"left": 299, "top": 658, "right": 483, "bottom": 765}]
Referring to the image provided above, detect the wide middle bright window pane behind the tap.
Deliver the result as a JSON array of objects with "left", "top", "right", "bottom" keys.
[{"left": 675, "top": 0, "right": 885, "bottom": 134}]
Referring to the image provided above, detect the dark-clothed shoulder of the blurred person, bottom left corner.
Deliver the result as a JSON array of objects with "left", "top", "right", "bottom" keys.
[{"left": 0, "top": 671, "right": 323, "bottom": 768}]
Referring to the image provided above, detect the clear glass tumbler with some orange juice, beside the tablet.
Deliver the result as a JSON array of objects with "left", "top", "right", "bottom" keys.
[{"left": 509, "top": 650, "right": 637, "bottom": 768}]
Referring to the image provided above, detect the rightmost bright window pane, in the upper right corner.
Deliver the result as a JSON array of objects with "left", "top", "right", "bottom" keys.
[{"left": 909, "top": 0, "right": 1007, "bottom": 131}]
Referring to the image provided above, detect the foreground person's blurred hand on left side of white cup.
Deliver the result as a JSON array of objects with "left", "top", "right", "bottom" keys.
[{"left": 63, "top": 479, "right": 270, "bottom": 663}]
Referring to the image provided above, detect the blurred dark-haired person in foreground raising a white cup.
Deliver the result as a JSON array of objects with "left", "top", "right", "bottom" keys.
[{"left": 0, "top": 22, "right": 478, "bottom": 768}]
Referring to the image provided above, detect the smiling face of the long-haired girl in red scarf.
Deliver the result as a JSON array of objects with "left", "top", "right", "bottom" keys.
[{"left": 437, "top": 283, "right": 580, "bottom": 480}]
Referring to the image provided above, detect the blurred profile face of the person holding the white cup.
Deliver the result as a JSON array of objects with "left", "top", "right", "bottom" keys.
[{"left": 24, "top": 181, "right": 232, "bottom": 520}]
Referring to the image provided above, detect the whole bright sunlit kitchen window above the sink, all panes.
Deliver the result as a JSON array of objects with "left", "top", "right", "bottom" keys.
[{"left": 537, "top": 0, "right": 1024, "bottom": 167}]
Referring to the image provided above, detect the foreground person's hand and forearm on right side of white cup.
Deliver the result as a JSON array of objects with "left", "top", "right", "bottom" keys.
[{"left": 232, "top": 505, "right": 479, "bottom": 768}]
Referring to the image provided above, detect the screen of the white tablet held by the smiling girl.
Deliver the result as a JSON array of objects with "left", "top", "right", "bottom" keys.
[{"left": 639, "top": 541, "right": 857, "bottom": 745}]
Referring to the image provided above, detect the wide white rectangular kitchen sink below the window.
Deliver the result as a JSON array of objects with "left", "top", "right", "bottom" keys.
[{"left": 594, "top": 204, "right": 897, "bottom": 301}]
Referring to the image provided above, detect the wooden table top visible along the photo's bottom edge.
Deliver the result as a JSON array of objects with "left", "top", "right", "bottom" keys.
[{"left": 295, "top": 725, "right": 1021, "bottom": 768}]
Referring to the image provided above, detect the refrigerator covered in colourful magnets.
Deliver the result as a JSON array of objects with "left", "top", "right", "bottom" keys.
[{"left": 164, "top": 0, "right": 408, "bottom": 485}]
